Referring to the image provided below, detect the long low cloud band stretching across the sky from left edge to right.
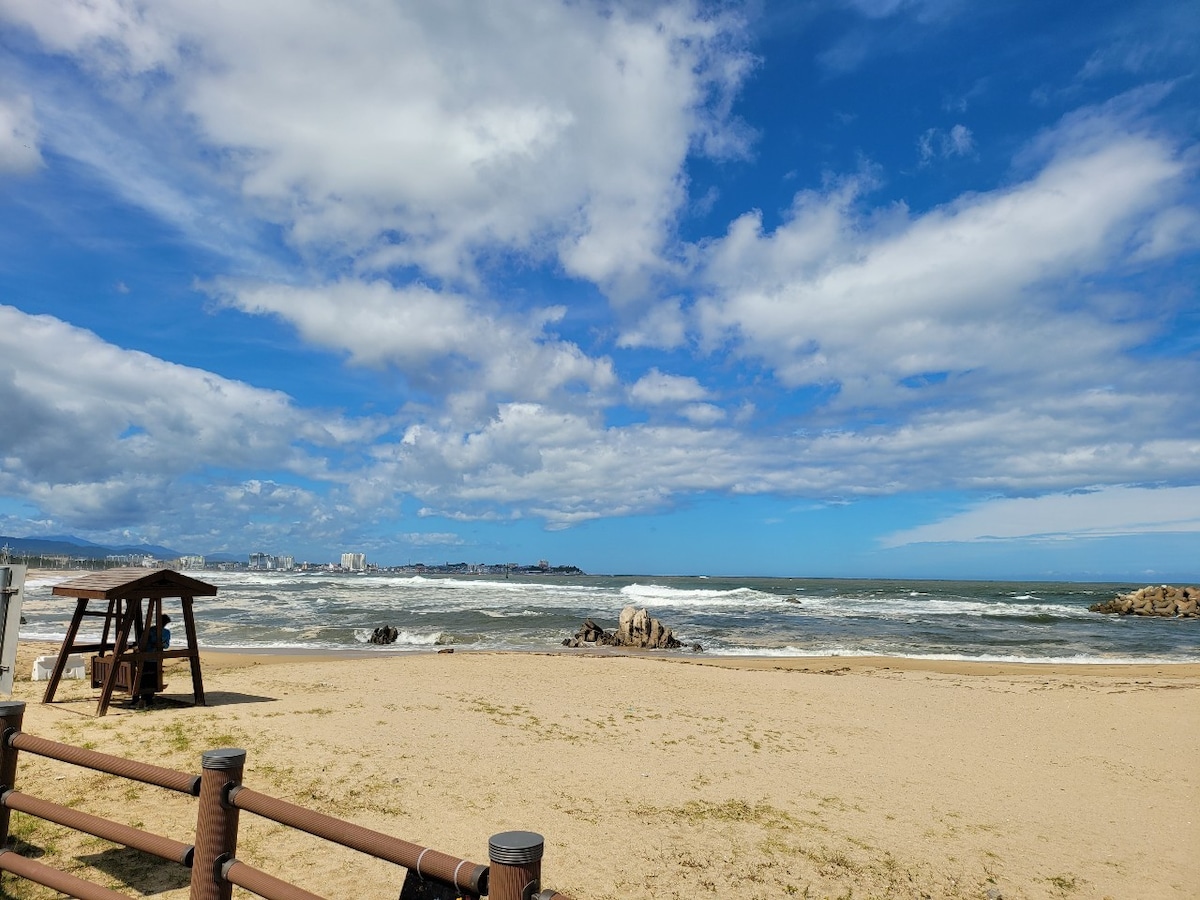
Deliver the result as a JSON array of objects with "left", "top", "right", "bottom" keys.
[{"left": 0, "top": 300, "right": 1200, "bottom": 546}]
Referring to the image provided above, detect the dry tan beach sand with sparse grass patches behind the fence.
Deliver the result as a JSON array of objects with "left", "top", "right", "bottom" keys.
[{"left": 5, "top": 646, "right": 1200, "bottom": 900}]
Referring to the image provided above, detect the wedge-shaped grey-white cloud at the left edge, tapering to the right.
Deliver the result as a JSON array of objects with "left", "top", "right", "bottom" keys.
[{"left": 0, "top": 306, "right": 355, "bottom": 524}]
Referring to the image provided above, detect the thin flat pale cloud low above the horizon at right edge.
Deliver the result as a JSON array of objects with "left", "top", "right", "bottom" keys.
[{"left": 883, "top": 485, "right": 1200, "bottom": 547}]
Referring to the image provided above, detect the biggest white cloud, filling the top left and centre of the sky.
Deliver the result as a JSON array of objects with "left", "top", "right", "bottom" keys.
[{"left": 4, "top": 0, "right": 751, "bottom": 293}]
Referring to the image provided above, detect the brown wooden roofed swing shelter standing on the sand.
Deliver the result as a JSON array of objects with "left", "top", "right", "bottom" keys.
[{"left": 42, "top": 569, "right": 217, "bottom": 715}]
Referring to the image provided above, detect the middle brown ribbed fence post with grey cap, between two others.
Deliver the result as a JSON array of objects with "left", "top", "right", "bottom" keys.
[{"left": 188, "top": 749, "right": 246, "bottom": 900}]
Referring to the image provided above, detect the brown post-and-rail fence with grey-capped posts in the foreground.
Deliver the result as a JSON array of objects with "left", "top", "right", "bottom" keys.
[{"left": 0, "top": 701, "right": 569, "bottom": 900}]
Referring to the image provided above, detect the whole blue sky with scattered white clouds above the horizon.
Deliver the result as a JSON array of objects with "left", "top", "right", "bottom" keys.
[{"left": 0, "top": 0, "right": 1200, "bottom": 582}]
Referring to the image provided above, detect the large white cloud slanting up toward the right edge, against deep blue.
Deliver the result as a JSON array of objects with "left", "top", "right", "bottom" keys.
[{"left": 697, "top": 111, "right": 1187, "bottom": 415}]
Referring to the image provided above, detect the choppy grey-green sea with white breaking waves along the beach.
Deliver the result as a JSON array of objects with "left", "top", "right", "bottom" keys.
[{"left": 20, "top": 571, "right": 1200, "bottom": 664}]
